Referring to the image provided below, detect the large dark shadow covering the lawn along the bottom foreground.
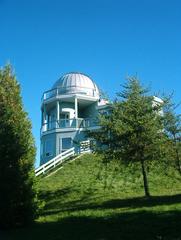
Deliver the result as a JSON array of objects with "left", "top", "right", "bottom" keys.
[{"left": 2, "top": 211, "right": 181, "bottom": 240}]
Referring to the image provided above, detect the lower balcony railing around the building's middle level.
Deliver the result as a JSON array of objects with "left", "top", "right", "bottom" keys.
[{"left": 41, "top": 118, "right": 99, "bottom": 134}]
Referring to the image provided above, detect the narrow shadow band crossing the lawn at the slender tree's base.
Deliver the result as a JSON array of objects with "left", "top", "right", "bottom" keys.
[{"left": 42, "top": 194, "right": 181, "bottom": 215}]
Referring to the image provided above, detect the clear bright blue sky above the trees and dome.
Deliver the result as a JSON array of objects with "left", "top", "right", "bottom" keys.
[{"left": 0, "top": 0, "right": 181, "bottom": 164}]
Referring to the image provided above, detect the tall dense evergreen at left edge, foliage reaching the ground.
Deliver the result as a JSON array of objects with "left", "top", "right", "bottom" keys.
[{"left": 0, "top": 65, "right": 38, "bottom": 228}]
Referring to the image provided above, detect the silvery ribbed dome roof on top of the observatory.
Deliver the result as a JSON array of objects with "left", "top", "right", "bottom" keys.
[{"left": 52, "top": 72, "right": 99, "bottom": 97}]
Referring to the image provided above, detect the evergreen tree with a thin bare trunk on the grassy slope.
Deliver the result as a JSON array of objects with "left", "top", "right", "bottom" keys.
[{"left": 92, "top": 77, "right": 164, "bottom": 197}]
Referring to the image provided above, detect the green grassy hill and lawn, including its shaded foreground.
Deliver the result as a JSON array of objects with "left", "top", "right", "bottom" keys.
[{"left": 0, "top": 154, "right": 181, "bottom": 240}]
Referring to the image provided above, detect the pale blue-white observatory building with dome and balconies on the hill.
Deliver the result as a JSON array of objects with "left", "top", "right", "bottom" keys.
[{"left": 40, "top": 72, "right": 108, "bottom": 165}]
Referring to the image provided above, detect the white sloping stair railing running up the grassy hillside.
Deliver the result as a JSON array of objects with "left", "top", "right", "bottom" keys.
[{"left": 35, "top": 147, "right": 75, "bottom": 176}]
